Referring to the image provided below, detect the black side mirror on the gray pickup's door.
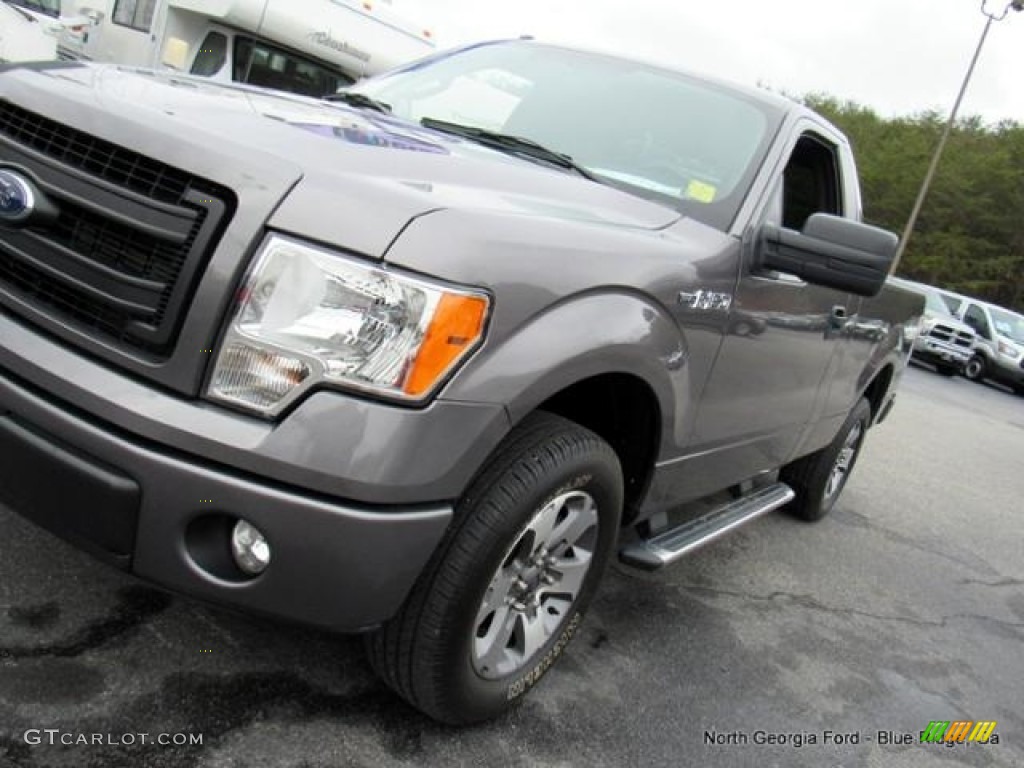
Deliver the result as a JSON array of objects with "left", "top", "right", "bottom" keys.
[{"left": 761, "top": 213, "right": 899, "bottom": 296}]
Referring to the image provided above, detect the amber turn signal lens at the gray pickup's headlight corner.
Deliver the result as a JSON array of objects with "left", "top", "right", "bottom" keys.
[{"left": 403, "top": 293, "right": 487, "bottom": 397}]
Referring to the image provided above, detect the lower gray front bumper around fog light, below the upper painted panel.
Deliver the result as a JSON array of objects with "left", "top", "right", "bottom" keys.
[{"left": 0, "top": 364, "right": 452, "bottom": 632}]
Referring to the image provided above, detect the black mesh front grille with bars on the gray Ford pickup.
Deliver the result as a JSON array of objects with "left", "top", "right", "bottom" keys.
[{"left": 0, "top": 101, "right": 234, "bottom": 358}]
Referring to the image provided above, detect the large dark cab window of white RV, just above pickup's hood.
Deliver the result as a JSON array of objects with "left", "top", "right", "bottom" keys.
[{"left": 231, "top": 36, "right": 354, "bottom": 97}]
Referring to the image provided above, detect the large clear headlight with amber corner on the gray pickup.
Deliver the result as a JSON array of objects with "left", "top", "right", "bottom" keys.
[{"left": 208, "top": 236, "right": 488, "bottom": 414}]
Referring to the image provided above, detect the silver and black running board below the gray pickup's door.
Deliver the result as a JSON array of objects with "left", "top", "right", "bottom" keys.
[{"left": 618, "top": 482, "right": 796, "bottom": 570}]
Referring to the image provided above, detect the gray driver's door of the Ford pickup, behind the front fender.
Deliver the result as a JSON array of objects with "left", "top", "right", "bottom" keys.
[{"left": 678, "top": 121, "right": 859, "bottom": 498}]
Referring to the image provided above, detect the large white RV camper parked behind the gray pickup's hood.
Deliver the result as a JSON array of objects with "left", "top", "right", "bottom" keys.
[{"left": 60, "top": 0, "right": 435, "bottom": 96}]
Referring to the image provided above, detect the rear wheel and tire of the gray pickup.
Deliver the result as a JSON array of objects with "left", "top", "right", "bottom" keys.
[{"left": 779, "top": 398, "right": 871, "bottom": 522}]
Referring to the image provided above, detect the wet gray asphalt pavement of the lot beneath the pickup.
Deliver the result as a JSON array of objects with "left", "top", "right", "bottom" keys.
[{"left": 0, "top": 369, "right": 1024, "bottom": 768}]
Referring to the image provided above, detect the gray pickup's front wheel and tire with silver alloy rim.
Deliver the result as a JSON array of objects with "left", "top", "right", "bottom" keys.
[{"left": 366, "top": 413, "right": 623, "bottom": 725}]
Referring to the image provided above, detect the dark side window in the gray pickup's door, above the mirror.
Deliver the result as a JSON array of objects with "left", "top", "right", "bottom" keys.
[{"left": 778, "top": 133, "right": 842, "bottom": 230}]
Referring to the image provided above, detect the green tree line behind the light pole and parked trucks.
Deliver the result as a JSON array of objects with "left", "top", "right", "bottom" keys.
[{"left": 803, "top": 94, "right": 1024, "bottom": 311}]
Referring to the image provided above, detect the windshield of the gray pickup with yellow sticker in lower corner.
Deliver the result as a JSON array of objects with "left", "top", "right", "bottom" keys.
[{"left": 353, "top": 41, "right": 779, "bottom": 229}]
